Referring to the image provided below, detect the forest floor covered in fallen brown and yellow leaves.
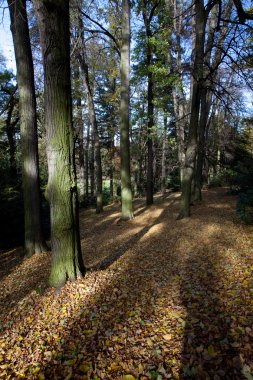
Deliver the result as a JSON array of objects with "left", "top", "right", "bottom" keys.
[{"left": 0, "top": 189, "right": 253, "bottom": 380}]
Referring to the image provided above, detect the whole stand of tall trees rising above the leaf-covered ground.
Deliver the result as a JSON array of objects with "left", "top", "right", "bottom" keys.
[{"left": 0, "top": 0, "right": 253, "bottom": 287}]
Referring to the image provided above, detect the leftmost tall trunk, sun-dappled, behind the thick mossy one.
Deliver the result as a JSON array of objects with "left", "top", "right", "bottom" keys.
[{"left": 8, "top": 0, "right": 47, "bottom": 256}]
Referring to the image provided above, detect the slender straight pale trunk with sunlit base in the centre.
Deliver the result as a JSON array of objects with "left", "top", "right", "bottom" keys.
[{"left": 120, "top": 0, "right": 133, "bottom": 220}]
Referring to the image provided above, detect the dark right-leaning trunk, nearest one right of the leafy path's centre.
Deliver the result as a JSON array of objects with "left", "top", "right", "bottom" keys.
[{"left": 178, "top": 0, "right": 206, "bottom": 219}]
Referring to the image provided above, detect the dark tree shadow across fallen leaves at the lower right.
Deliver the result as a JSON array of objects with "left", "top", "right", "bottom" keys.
[{"left": 181, "top": 247, "right": 243, "bottom": 379}]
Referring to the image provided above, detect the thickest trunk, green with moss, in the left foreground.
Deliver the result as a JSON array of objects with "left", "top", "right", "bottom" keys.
[{"left": 33, "top": 0, "right": 85, "bottom": 288}]
